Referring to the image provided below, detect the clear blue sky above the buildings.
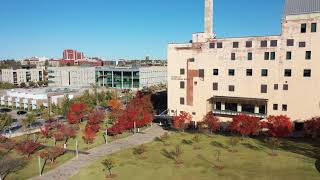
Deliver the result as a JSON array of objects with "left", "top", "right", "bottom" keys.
[{"left": 0, "top": 0, "right": 284, "bottom": 59}]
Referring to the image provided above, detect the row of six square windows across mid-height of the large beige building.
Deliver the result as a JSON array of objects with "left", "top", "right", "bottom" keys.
[{"left": 213, "top": 69, "right": 311, "bottom": 77}]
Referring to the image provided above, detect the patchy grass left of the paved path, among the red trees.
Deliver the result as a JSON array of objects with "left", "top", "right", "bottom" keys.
[{"left": 2, "top": 123, "right": 145, "bottom": 180}]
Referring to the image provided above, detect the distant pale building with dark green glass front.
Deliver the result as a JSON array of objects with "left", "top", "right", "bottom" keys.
[{"left": 96, "top": 66, "right": 167, "bottom": 89}]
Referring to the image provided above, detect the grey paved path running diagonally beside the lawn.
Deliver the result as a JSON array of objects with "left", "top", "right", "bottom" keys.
[{"left": 31, "top": 125, "right": 166, "bottom": 180}]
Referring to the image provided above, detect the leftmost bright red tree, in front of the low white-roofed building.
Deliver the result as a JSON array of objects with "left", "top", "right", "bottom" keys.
[{"left": 67, "top": 103, "right": 87, "bottom": 124}]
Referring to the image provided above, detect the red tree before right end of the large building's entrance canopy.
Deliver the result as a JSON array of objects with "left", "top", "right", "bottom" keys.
[{"left": 228, "top": 114, "right": 260, "bottom": 136}]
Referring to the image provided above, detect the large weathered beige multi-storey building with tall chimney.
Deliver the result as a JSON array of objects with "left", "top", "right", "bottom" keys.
[{"left": 168, "top": 0, "right": 320, "bottom": 125}]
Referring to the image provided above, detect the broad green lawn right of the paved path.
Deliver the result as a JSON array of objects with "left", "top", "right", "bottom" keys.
[{"left": 70, "top": 133, "right": 320, "bottom": 180}]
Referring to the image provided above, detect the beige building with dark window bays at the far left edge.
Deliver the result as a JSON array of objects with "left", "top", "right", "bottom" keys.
[{"left": 1, "top": 68, "right": 45, "bottom": 85}]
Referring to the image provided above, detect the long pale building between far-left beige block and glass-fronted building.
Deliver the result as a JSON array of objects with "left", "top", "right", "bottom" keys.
[{"left": 48, "top": 66, "right": 96, "bottom": 87}]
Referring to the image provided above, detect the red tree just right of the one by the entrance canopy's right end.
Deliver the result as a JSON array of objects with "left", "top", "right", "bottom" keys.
[{"left": 264, "top": 115, "right": 292, "bottom": 156}]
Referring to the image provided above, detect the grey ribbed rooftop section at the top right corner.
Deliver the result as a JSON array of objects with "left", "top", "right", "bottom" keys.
[{"left": 285, "top": 0, "right": 320, "bottom": 16}]
